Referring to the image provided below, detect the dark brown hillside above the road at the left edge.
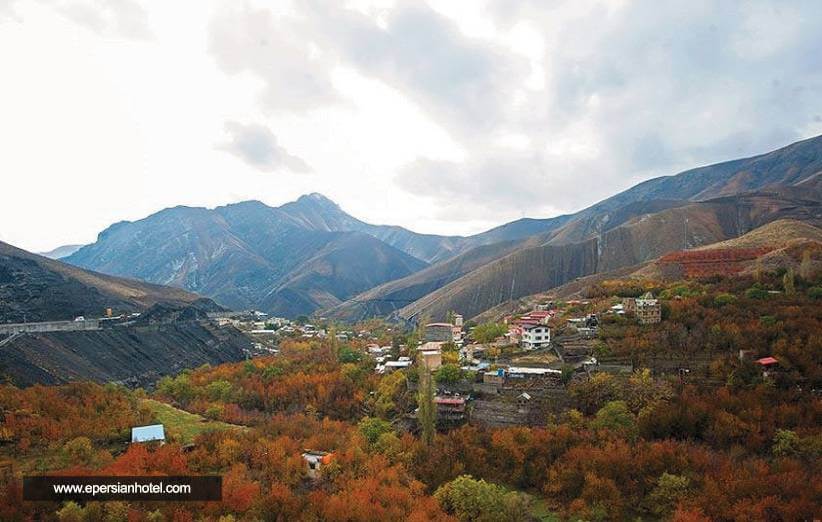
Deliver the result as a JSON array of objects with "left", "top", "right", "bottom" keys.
[{"left": 0, "top": 243, "right": 200, "bottom": 323}]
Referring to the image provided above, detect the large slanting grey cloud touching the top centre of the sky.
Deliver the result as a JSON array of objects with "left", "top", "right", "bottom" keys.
[{"left": 300, "top": 0, "right": 530, "bottom": 141}]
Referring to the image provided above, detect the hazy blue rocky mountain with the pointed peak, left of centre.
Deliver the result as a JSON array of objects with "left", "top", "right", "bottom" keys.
[{"left": 67, "top": 196, "right": 426, "bottom": 316}]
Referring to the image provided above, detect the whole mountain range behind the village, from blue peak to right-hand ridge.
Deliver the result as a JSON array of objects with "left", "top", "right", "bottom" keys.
[{"left": 65, "top": 132, "right": 822, "bottom": 319}]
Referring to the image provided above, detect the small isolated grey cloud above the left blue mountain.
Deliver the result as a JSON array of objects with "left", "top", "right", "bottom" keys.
[{"left": 219, "top": 121, "right": 311, "bottom": 173}]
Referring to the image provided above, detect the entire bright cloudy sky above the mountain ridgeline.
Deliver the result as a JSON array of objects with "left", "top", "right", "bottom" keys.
[{"left": 0, "top": 0, "right": 822, "bottom": 251}]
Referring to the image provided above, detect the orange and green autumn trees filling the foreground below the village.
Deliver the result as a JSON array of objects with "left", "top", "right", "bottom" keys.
[{"left": 0, "top": 272, "right": 822, "bottom": 521}]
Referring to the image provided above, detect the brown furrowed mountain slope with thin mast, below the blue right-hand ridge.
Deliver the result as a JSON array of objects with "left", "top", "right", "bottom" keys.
[{"left": 399, "top": 190, "right": 822, "bottom": 319}]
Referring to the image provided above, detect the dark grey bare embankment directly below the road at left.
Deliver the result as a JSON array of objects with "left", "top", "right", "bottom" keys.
[{"left": 0, "top": 321, "right": 251, "bottom": 386}]
